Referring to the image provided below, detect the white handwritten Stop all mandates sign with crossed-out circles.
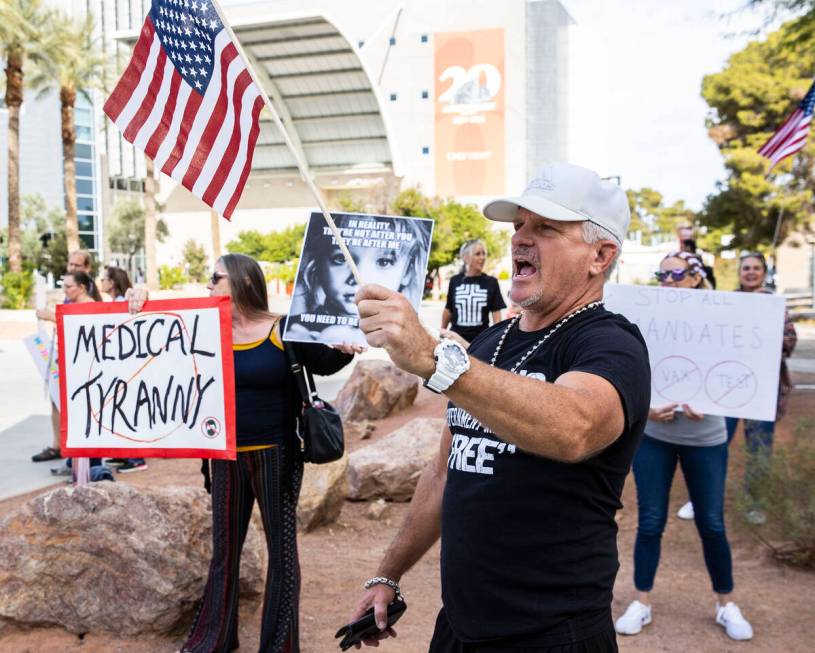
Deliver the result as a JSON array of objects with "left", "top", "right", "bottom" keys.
[{"left": 605, "top": 284, "right": 784, "bottom": 421}]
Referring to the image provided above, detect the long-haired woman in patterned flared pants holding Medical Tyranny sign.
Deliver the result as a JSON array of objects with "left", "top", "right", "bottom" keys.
[{"left": 128, "top": 254, "right": 362, "bottom": 653}]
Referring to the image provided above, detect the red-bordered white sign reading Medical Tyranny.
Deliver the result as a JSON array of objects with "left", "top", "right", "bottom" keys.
[{"left": 57, "top": 297, "right": 236, "bottom": 460}]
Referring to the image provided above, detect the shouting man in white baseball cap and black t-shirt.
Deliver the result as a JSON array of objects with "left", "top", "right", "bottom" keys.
[{"left": 352, "top": 164, "right": 651, "bottom": 653}]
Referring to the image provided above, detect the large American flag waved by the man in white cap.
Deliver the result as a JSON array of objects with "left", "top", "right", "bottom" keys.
[{"left": 104, "top": 0, "right": 263, "bottom": 218}]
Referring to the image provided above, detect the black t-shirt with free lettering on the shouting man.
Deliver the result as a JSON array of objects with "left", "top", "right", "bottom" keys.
[{"left": 441, "top": 308, "right": 651, "bottom": 646}]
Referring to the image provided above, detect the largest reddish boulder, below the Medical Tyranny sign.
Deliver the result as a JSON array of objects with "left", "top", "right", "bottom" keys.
[{"left": 0, "top": 482, "right": 266, "bottom": 636}]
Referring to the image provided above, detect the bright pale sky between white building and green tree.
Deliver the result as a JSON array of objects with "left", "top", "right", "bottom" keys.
[{"left": 561, "top": 0, "right": 776, "bottom": 208}]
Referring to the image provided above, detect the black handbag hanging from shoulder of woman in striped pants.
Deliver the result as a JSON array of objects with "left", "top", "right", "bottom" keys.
[{"left": 283, "top": 342, "right": 345, "bottom": 465}]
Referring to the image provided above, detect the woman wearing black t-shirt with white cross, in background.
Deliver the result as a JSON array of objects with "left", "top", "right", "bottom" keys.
[{"left": 441, "top": 239, "right": 507, "bottom": 343}]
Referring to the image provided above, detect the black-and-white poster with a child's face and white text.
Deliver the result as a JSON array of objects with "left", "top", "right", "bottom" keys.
[{"left": 283, "top": 213, "right": 440, "bottom": 345}]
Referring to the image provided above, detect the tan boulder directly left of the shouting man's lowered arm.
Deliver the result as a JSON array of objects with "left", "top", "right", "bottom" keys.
[{"left": 348, "top": 418, "right": 444, "bottom": 501}]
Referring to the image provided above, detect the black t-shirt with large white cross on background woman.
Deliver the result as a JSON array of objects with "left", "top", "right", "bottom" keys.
[{"left": 445, "top": 272, "right": 507, "bottom": 342}]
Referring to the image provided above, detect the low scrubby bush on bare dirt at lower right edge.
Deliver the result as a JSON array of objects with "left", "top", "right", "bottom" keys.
[{"left": 739, "top": 436, "right": 815, "bottom": 568}]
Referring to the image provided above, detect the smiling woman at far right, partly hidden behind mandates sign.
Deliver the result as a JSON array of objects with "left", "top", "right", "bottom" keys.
[{"left": 725, "top": 252, "right": 798, "bottom": 524}]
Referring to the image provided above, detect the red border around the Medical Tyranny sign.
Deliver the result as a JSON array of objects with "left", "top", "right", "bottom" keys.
[{"left": 57, "top": 297, "right": 237, "bottom": 460}]
